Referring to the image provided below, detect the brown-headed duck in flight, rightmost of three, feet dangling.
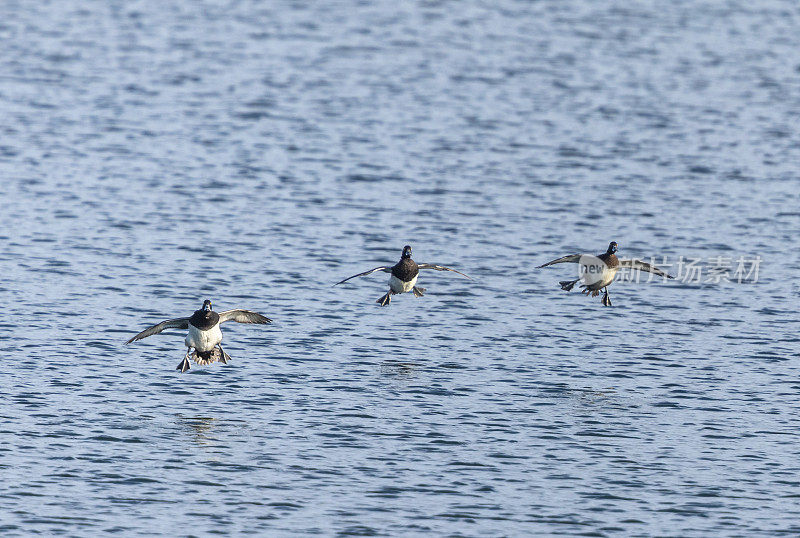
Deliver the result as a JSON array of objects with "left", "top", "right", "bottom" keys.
[{"left": 537, "top": 241, "right": 674, "bottom": 306}]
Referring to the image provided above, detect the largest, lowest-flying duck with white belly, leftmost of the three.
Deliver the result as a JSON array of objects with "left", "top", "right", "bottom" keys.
[{"left": 125, "top": 299, "right": 272, "bottom": 372}]
